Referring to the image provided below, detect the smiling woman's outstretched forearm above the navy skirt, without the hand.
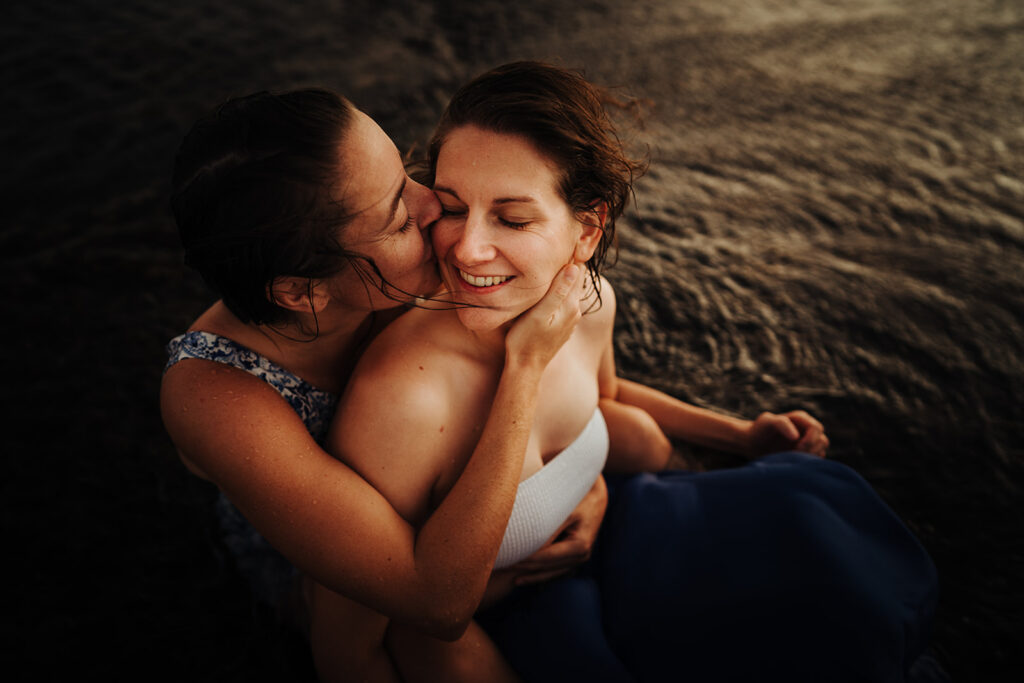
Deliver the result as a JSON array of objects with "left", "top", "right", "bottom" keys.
[{"left": 613, "top": 378, "right": 751, "bottom": 454}]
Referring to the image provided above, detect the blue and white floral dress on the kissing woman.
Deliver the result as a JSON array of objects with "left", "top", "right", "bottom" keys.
[{"left": 164, "top": 332, "right": 338, "bottom": 607}]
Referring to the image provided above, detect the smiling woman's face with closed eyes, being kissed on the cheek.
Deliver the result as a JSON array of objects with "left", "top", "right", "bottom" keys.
[{"left": 433, "top": 125, "right": 600, "bottom": 331}]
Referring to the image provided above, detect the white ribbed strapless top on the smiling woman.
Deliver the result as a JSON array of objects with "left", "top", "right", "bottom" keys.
[{"left": 495, "top": 410, "right": 608, "bottom": 569}]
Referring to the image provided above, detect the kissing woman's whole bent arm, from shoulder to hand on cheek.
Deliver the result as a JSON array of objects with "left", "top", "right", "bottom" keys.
[{"left": 155, "top": 268, "right": 580, "bottom": 639}]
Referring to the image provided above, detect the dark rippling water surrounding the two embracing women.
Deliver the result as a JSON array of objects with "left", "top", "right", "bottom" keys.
[{"left": 0, "top": 0, "right": 1024, "bottom": 681}]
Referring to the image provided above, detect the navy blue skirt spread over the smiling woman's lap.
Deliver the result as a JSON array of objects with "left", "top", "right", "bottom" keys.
[{"left": 479, "top": 453, "right": 938, "bottom": 683}]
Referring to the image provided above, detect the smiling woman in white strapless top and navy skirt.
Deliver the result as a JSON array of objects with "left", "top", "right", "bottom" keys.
[{"left": 325, "top": 62, "right": 934, "bottom": 681}]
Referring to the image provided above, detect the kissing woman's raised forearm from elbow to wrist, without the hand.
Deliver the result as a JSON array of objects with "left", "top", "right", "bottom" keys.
[{"left": 415, "top": 364, "right": 543, "bottom": 636}]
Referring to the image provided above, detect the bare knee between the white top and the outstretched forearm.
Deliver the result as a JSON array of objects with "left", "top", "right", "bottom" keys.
[{"left": 599, "top": 398, "right": 673, "bottom": 473}]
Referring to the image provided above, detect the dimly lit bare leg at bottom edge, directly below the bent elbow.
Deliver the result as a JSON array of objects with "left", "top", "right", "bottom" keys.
[{"left": 385, "top": 622, "right": 520, "bottom": 683}]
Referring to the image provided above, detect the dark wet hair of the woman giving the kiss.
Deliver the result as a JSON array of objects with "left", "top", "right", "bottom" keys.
[{"left": 171, "top": 88, "right": 403, "bottom": 327}]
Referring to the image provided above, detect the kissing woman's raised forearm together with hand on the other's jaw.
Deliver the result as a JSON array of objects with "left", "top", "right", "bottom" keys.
[{"left": 354, "top": 265, "right": 581, "bottom": 640}]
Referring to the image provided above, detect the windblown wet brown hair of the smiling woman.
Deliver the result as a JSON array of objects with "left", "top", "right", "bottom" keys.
[{"left": 428, "top": 61, "right": 646, "bottom": 295}]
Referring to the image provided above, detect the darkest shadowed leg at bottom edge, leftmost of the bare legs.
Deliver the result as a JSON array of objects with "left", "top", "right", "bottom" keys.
[{"left": 306, "top": 580, "right": 401, "bottom": 683}]
